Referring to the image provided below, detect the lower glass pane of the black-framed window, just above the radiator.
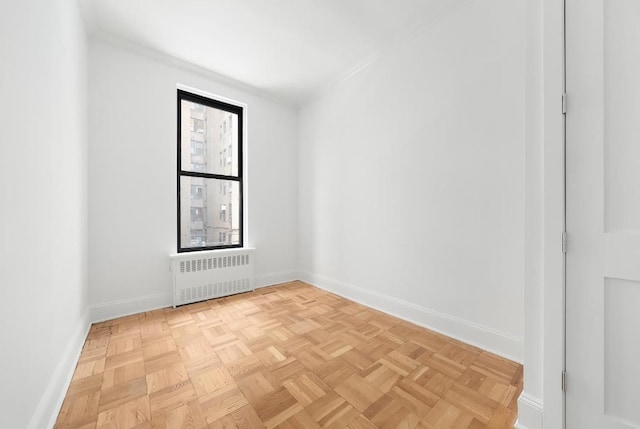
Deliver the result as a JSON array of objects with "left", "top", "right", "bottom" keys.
[{"left": 180, "top": 176, "right": 240, "bottom": 248}]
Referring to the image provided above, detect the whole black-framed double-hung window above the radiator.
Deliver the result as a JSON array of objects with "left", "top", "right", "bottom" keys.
[{"left": 177, "top": 90, "right": 243, "bottom": 252}]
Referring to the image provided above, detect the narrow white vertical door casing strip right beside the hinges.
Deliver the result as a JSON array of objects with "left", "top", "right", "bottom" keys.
[{"left": 533, "top": 0, "right": 570, "bottom": 428}]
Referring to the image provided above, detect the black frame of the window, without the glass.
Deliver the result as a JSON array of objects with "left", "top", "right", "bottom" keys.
[{"left": 176, "top": 89, "right": 244, "bottom": 253}]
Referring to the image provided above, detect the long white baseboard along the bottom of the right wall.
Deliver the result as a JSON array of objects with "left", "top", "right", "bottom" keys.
[{"left": 299, "top": 271, "right": 523, "bottom": 363}]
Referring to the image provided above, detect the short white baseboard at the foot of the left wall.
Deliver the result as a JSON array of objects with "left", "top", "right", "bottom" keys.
[{"left": 27, "top": 313, "right": 91, "bottom": 429}]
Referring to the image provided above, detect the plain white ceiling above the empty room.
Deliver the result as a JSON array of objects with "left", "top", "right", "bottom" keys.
[{"left": 84, "top": 0, "right": 460, "bottom": 104}]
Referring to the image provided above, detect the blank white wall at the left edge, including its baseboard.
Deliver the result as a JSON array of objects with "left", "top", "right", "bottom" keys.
[{"left": 0, "top": 0, "right": 89, "bottom": 429}]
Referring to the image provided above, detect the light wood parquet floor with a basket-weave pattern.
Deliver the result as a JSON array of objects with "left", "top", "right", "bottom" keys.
[{"left": 56, "top": 282, "right": 522, "bottom": 429}]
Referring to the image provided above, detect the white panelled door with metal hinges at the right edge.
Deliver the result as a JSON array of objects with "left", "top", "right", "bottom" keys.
[{"left": 566, "top": 0, "right": 640, "bottom": 429}]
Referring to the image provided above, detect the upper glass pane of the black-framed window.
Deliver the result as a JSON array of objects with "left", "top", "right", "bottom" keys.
[{"left": 180, "top": 100, "right": 239, "bottom": 176}]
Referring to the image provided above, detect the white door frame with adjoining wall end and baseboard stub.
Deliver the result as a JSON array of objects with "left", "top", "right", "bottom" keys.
[{"left": 516, "top": 0, "right": 571, "bottom": 429}]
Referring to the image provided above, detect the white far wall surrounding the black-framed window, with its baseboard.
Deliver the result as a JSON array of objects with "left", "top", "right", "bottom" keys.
[{"left": 89, "top": 40, "right": 298, "bottom": 320}]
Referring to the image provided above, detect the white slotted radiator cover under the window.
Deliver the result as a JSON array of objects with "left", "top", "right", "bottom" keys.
[{"left": 170, "top": 248, "right": 255, "bottom": 307}]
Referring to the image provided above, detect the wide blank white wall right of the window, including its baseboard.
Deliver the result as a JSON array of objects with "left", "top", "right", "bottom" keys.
[{"left": 299, "top": 0, "right": 526, "bottom": 361}]
